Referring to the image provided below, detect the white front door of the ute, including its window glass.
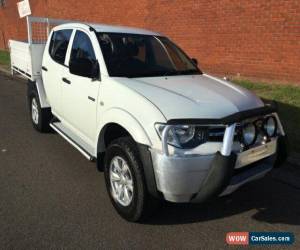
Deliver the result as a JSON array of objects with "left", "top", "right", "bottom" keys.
[{"left": 62, "top": 30, "right": 99, "bottom": 144}]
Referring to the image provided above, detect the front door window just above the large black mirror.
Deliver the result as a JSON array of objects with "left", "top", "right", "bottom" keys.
[{"left": 70, "top": 31, "right": 96, "bottom": 63}]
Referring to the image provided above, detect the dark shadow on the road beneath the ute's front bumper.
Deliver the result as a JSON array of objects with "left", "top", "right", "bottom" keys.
[{"left": 146, "top": 175, "right": 300, "bottom": 225}]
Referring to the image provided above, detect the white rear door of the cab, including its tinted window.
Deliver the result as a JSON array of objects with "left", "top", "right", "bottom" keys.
[{"left": 42, "top": 29, "right": 73, "bottom": 116}]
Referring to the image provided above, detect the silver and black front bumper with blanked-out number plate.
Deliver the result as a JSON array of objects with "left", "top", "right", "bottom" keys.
[{"left": 151, "top": 138, "right": 282, "bottom": 202}]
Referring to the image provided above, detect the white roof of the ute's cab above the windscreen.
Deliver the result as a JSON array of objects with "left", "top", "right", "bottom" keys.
[{"left": 55, "top": 22, "right": 161, "bottom": 36}]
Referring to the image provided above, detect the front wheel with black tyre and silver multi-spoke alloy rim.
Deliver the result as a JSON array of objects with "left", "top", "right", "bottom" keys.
[{"left": 104, "top": 137, "right": 159, "bottom": 222}]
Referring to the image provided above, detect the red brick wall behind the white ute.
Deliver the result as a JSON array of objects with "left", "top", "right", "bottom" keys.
[{"left": 0, "top": 0, "right": 300, "bottom": 84}]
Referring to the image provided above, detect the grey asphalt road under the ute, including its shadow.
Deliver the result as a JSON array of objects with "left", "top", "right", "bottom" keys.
[{"left": 0, "top": 74, "right": 300, "bottom": 249}]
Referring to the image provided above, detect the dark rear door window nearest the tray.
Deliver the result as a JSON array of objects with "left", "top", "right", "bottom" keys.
[{"left": 49, "top": 30, "right": 72, "bottom": 64}]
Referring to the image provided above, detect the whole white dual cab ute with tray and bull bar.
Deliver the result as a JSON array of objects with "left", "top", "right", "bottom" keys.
[{"left": 10, "top": 17, "right": 286, "bottom": 221}]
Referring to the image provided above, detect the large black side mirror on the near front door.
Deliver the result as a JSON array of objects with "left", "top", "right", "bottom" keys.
[{"left": 69, "top": 58, "right": 100, "bottom": 80}]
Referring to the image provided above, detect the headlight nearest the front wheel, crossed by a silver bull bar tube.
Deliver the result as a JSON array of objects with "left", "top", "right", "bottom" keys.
[{"left": 155, "top": 124, "right": 208, "bottom": 148}]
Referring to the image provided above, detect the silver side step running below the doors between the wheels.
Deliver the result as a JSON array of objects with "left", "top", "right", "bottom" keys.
[{"left": 50, "top": 121, "right": 96, "bottom": 161}]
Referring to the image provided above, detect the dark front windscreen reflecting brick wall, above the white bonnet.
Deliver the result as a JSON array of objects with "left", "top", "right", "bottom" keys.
[{"left": 97, "top": 33, "right": 201, "bottom": 77}]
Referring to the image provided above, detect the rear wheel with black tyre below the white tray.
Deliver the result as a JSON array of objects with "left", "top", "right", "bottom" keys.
[{"left": 28, "top": 91, "right": 52, "bottom": 133}]
